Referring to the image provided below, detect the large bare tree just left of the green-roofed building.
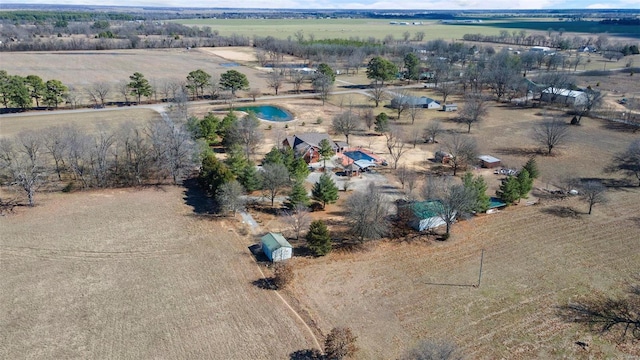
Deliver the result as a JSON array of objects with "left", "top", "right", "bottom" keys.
[{"left": 345, "top": 183, "right": 389, "bottom": 242}]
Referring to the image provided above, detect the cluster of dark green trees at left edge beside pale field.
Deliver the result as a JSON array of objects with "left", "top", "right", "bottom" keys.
[{"left": 0, "top": 70, "right": 69, "bottom": 110}]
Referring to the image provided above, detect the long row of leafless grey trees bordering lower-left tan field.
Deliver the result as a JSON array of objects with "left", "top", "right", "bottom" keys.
[{"left": 0, "top": 115, "right": 198, "bottom": 205}]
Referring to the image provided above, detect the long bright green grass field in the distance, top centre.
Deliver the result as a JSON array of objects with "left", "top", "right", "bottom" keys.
[{"left": 175, "top": 19, "right": 499, "bottom": 40}]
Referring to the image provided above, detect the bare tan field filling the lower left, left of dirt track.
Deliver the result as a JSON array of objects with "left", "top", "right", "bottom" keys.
[{"left": 0, "top": 187, "right": 314, "bottom": 359}]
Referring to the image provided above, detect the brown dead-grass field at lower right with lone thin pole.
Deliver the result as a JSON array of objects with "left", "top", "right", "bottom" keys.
[{"left": 295, "top": 189, "right": 640, "bottom": 359}]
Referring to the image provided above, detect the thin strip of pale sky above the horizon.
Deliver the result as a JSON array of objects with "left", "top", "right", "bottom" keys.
[{"left": 7, "top": 0, "right": 640, "bottom": 10}]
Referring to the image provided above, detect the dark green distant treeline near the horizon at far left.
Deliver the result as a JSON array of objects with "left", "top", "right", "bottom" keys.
[{"left": 0, "top": 10, "right": 144, "bottom": 22}]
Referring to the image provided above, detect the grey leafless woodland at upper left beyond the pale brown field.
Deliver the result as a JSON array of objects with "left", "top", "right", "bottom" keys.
[{"left": 0, "top": 12, "right": 251, "bottom": 51}]
